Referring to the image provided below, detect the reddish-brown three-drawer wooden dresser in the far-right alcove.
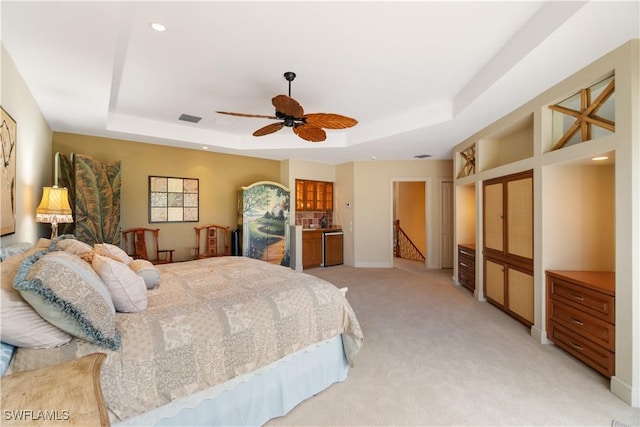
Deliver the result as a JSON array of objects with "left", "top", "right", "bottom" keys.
[{"left": 546, "top": 270, "right": 615, "bottom": 377}]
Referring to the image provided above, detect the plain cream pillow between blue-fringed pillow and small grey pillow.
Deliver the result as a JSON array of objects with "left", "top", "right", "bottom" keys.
[{"left": 91, "top": 254, "right": 147, "bottom": 313}]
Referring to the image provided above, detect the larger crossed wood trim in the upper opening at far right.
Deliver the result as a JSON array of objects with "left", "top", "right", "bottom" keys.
[{"left": 549, "top": 79, "right": 616, "bottom": 150}]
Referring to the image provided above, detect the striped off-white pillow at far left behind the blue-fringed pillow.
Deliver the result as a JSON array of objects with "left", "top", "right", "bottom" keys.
[{"left": 0, "top": 252, "right": 72, "bottom": 348}]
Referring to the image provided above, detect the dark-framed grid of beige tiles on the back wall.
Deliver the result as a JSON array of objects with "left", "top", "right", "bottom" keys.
[{"left": 149, "top": 176, "right": 199, "bottom": 223}]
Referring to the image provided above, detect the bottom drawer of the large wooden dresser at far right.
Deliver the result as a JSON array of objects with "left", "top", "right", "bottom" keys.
[{"left": 549, "top": 320, "right": 615, "bottom": 377}]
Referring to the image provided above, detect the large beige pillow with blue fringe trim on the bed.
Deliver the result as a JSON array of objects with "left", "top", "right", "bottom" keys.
[{"left": 13, "top": 251, "right": 120, "bottom": 350}]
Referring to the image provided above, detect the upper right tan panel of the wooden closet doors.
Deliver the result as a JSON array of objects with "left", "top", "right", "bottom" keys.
[{"left": 506, "top": 177, "right": 533, "bottom": 259}]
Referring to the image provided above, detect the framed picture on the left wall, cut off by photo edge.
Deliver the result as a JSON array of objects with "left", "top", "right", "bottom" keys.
[{"left": 0, "top": 107, "right": 18, "bottom": 236}]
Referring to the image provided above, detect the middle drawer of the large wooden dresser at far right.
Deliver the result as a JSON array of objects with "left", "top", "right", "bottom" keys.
[{"left": 549, "top": 299, "right": 615, "bottom": 351}]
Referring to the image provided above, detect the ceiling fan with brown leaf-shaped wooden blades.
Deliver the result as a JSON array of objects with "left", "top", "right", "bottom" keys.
[{"left": 216, "top": 71, "right": 358, "bottom": 142}]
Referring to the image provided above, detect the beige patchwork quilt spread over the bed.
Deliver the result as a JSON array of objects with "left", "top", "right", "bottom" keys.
[{"left": 8, "top": 257, "right": 363, "bottom": 420}]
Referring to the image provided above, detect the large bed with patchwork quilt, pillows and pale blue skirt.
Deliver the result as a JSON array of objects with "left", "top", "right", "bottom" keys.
[{"left": 0, "top": 239, "right": 363, "bottom": 426}]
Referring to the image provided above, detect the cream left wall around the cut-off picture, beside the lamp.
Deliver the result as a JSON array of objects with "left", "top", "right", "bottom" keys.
[{"left": 0, "top": 45, "right": 52, "bottom": 246}]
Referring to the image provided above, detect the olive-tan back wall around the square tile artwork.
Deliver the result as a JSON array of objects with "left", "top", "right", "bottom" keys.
[{"left": 53, "top": 132, "right": 280, "bottom": 260}]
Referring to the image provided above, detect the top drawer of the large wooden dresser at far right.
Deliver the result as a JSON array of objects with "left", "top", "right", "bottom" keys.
[{"left": 548, "top": 277, "right": 615, "bottom": 323}]
